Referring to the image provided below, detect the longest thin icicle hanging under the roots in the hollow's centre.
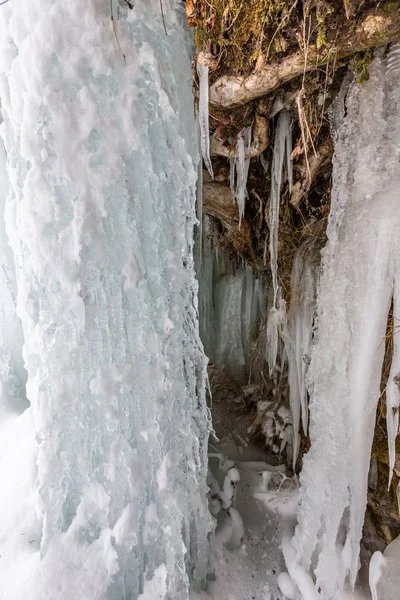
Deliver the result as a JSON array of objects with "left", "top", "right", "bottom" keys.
[{"left": 267, "top": 110, "right": 293, "bottom": 375}]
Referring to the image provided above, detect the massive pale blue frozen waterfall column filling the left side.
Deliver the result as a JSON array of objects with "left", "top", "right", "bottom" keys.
[{"left": 0, "top": 0, "right": 209, "bottom": 600}]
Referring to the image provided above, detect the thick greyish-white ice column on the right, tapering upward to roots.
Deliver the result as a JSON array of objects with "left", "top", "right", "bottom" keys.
[{"left": 288, "top": 48, "right": 400, "bottom": 600}]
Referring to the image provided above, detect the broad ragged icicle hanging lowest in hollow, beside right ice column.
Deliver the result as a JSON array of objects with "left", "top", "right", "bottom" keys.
[{"left": 282, "top": 238, "right": 319, "bottom": 468}]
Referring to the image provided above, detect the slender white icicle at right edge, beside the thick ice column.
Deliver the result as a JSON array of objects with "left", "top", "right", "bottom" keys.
[{"left": 386, "top": 276, "right": 400, "bottom": 489}]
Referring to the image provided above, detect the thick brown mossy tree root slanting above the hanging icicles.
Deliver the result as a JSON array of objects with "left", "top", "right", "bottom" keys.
[{"left": 210, "top": 3, "right": 400, "bottom": 108}]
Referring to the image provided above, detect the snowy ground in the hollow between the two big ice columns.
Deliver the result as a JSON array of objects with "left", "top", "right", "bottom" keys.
[{"left": 194, "top": 420, "right": 293, "bottom": 600}]
